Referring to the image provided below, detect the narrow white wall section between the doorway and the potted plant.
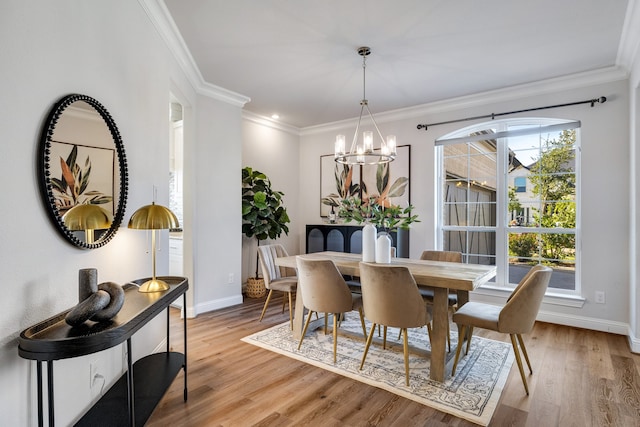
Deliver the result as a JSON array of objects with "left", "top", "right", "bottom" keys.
[{"left": 185, "top": 97, "right": 242, "bottom": 316}]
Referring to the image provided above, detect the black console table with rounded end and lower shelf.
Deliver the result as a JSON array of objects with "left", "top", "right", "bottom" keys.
[{"left": 18, "top": 276, "right": 189, "bottom": 427}]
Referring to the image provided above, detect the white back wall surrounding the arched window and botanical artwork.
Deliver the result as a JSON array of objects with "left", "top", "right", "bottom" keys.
[{"left": 298, "top": 70, "right": 630, "bottom": 334}]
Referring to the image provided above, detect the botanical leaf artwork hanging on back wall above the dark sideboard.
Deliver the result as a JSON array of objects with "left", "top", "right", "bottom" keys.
[{"left": 320, "top": 145, "right": 411, "bottom": 217}]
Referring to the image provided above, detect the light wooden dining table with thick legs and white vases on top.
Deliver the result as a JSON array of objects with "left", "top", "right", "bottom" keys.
[{"left": 275, "top": 251, "right": 496, "bottom": 382}]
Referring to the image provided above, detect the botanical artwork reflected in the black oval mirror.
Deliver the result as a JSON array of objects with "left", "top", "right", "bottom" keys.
[{"left": 50, "top": 141, "right": 116, "bottom": 216}]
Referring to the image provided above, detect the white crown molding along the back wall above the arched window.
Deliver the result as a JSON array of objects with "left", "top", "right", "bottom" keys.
[{"left": 300, "top": 66, "right": 629, "bottom": 136}]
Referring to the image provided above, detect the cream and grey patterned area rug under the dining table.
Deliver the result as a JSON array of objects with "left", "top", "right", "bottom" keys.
[{"left": 242, "top": 312, "right": 513, "bottom": 426}]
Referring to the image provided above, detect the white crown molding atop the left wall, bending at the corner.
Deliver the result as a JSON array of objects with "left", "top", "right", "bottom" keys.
[{"left": 138, "top": 0, "right": 251, "bottom": 108}]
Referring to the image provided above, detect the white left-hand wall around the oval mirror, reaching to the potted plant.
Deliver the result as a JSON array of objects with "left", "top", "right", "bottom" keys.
[{"left": 0, "top": 0, "right": 241, "bottom": 426}]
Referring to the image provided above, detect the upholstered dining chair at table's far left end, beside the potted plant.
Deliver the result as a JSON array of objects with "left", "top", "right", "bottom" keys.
[{"left": 258, "top": 244, "right": 298, "bottom": 329}]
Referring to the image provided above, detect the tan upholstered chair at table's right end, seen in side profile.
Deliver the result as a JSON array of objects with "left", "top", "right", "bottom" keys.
[{"left": 451, "top": 265, "right": 553, "bottom": 395}]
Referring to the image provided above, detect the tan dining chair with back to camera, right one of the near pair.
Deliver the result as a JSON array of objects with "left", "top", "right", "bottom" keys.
[{"left": 360, "top": 262, "right": 431, "bottom": 385}]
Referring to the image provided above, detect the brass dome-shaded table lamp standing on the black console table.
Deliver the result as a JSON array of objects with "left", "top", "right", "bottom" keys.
[{"left": 128, "top": 202, "right": 180, "bottom": 292}]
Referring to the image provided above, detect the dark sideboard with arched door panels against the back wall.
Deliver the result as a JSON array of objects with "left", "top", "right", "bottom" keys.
[{"left": 305, "top": 224, "right": 409, "bottom": 258}]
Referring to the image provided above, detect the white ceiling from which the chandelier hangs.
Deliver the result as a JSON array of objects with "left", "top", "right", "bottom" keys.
[{"left": 164, "top": 0, "right": 627, "bottom": 128}]
